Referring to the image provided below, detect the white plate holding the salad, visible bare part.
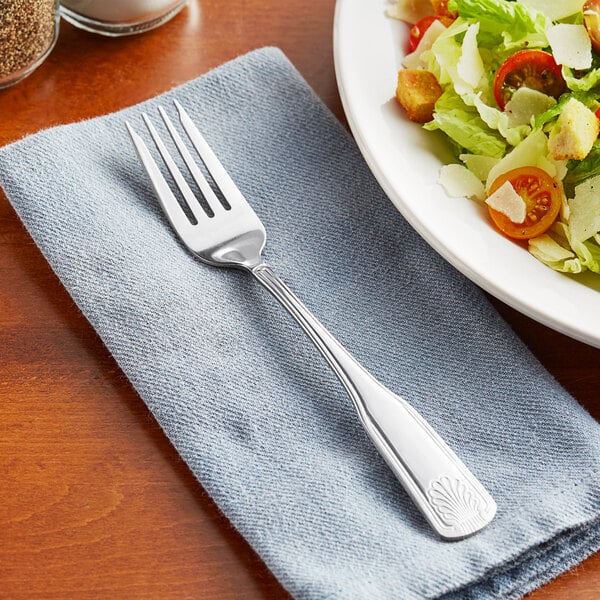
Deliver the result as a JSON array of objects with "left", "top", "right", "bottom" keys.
[{"left": 334, "top": 0, "right": 600, "bottom": 347}]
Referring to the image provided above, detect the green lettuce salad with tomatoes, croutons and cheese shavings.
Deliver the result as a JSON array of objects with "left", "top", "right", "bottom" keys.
[{"left": 388, "top": 0, "right": 600, "bottom": 273}]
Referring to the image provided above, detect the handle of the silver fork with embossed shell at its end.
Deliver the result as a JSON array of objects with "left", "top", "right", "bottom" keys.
[{"left": 250, "top": 263, "right": 496, "bottom": 540}]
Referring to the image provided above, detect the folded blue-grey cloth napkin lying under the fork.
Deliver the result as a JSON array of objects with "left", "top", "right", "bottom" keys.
[{"left": 0, "top": 48, "right": 600, "bottom": 600}]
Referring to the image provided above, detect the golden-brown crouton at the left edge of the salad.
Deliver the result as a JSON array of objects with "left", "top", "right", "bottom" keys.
[{"left": 396, "top": 69, "right": 442, "bottom": 123}]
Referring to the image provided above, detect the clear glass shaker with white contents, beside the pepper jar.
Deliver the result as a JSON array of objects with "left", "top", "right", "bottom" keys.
[{"left": 61, "top": 0, "right": 187, "bottom": 36}]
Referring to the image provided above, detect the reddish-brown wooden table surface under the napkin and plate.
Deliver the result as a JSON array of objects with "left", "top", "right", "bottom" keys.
[{"left": 0, "top": 0, "right": 600, "bottom": 600}]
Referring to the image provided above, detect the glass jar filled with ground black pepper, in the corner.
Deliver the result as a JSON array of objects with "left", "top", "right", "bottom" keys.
[{"left": 0, "top": 0, "right": 58, "bottom": 88}]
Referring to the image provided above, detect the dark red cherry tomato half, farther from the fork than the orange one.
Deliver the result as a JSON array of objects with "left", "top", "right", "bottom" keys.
[{"left": 494, "top": 50, "right": 567, "bottom": 110}]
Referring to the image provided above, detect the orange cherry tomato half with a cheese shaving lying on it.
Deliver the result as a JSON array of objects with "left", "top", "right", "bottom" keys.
[{"left": 488, "top": 167, "right": 562, "bottom": 240}]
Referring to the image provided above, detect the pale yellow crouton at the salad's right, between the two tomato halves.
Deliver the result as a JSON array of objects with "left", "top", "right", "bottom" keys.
[{"left": 548, "top": 98, "right": 600, "bottom": 160}]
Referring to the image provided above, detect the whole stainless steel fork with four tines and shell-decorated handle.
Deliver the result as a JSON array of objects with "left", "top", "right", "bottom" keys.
[{"left": 127, "top": 102, "right": 496, "bottom": 540}]
